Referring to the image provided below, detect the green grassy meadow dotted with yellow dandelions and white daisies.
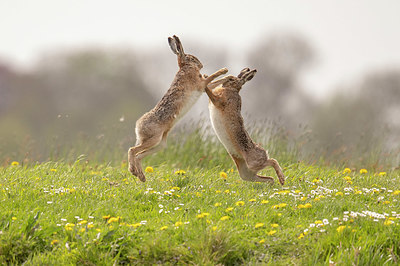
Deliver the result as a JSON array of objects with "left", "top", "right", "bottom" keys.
[{"left": 0, "top": 129, "right": 400, "bottom": 265}]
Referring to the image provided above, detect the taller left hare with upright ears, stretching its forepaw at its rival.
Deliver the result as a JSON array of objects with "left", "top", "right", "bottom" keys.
[{"left": 128, "top": 35, "right": 228, "bottom": 182}]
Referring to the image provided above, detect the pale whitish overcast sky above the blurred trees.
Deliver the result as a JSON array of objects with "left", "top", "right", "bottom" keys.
[{"left": 0, "top": 0, "right": 400, "bottom": 97}]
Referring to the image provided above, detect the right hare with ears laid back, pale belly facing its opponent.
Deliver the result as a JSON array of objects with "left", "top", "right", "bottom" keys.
[{"left": 205, "top": 68, "right": 285, "bottom": 185}]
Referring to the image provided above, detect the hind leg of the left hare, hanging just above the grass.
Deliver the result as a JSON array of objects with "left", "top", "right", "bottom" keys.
[{"left": 128, "top": 134, "right": 163, "bottom": 182}]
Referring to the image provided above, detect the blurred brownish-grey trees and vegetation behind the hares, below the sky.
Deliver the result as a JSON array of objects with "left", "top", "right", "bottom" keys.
[{"left": 0, "top": 33, "right": 400, "bottom": 168}]
